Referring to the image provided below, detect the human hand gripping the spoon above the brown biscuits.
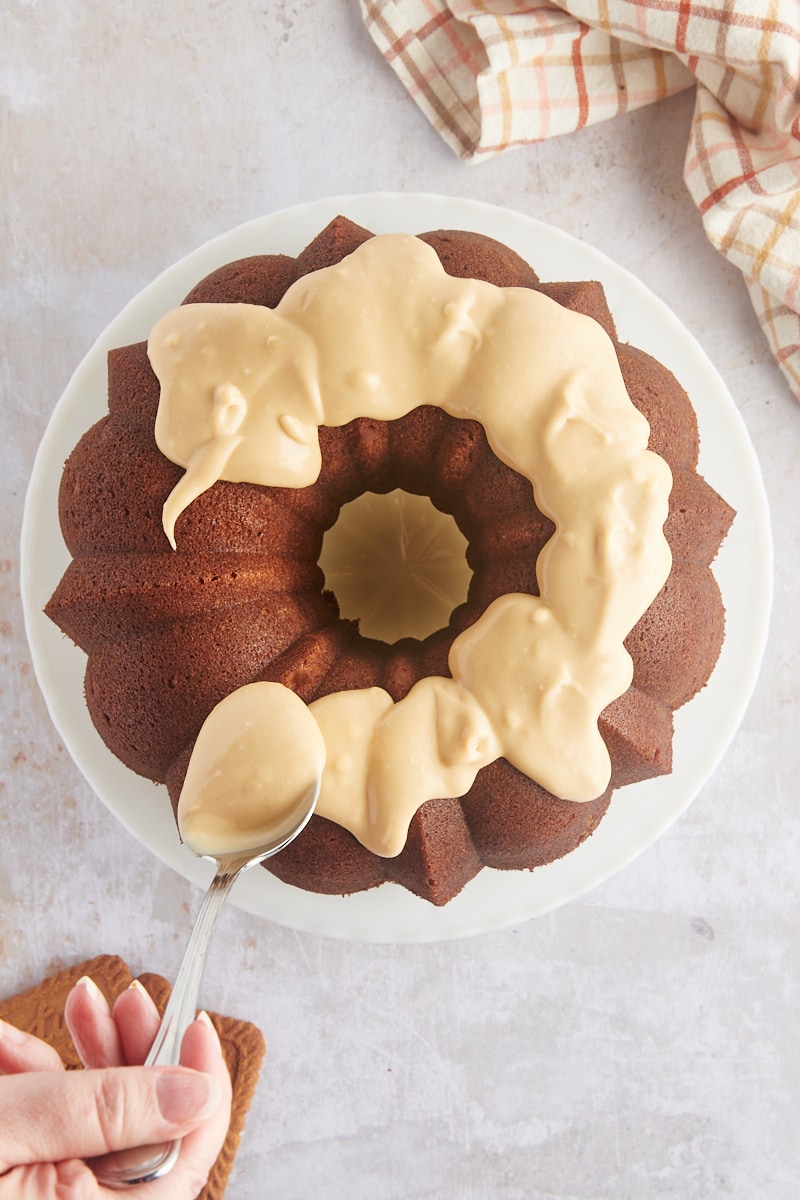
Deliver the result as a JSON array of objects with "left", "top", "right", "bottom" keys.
[{"left": 0, "top": 979, "right": 230, "bottom": 1200}]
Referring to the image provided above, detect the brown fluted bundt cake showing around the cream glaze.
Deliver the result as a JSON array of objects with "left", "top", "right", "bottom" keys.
[{"left": 46, "top": 217, "right": 733, "bottom": 905}]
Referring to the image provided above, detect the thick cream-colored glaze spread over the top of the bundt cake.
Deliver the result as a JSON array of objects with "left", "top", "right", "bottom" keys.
[{"left": 149, "top": 234, "right": 672, "bottom": 856}]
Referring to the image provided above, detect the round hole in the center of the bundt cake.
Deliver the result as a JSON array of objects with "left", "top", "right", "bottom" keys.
[{"left": 319, "top": 488, "right": 473, "bottom": 643}]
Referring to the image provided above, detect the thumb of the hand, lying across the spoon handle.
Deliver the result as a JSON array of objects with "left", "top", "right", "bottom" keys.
[{"left": 0, "top": 1067, "right": 222, "bottom": 1175}]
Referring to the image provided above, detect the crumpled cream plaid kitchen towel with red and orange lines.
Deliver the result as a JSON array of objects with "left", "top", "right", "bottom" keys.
[{"left": 360, "top": 0, "right": 800, "bottom": 400}]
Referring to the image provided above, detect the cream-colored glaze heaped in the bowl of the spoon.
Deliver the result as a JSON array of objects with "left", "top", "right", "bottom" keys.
[{"left": 178, "top": 683, "right": 326, "bottom": 858}]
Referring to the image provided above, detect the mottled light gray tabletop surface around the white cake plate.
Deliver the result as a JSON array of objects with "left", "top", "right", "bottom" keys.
[{"left": 0, "top": 0, "right": 800, "bottom": 1200}]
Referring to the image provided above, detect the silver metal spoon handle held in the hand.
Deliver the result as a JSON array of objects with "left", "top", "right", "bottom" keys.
[{"left": 90, "top": 860, "right": 245, "bottom": 1189}]
